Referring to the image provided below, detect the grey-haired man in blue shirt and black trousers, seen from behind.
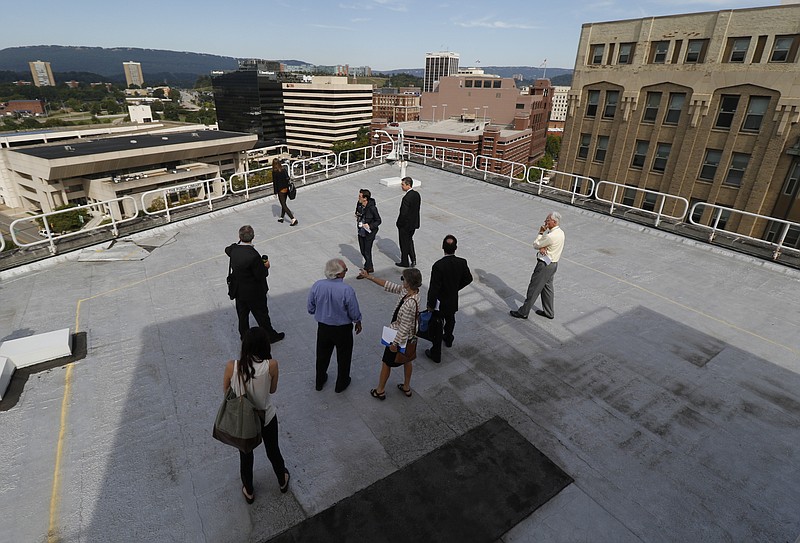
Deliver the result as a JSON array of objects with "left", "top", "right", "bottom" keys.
[{"left": 308, "top": 258, "right": 361, "bottom": 392}]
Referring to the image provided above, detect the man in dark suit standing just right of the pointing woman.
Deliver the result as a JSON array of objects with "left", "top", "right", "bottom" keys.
[{"left": 425, "top": 235, "right": 472, "bottom": 363}]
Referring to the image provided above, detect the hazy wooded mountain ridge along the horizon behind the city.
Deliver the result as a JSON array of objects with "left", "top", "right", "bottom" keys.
[{"left": 0, "top": 45, "right": 572, "bottom": 86}]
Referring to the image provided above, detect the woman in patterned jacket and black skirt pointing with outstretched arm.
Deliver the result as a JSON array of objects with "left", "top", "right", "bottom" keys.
[{"left": 358, "top": 268, "right": 422, "bottom": 400}]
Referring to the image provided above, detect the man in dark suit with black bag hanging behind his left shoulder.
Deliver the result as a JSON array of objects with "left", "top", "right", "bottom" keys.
[{"left": 225, "top": 224, "right": 286, "bottom": 343}]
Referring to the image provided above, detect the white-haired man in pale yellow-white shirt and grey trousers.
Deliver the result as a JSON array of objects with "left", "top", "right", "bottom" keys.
[{"left": 509, "top": 211, "right": 564, "bottom": 319}]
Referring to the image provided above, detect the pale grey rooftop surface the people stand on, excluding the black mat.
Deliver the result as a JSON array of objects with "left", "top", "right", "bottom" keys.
[{"left": 0, "top": 164, "right": 800, "bottom": 543}]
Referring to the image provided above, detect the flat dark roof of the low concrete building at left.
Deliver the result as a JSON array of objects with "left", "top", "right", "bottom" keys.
[{"left": 10, "top": 130, "right": 252, "bottom": 160}]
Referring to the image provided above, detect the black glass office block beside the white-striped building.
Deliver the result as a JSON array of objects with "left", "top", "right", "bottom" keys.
[{"left": 211, "top": 59, "right": 292, "bottom": 146}]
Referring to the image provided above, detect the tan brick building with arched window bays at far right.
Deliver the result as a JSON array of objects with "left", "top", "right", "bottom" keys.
[{"left": 559, "top": 4, "right": 800, "bottom": 247}]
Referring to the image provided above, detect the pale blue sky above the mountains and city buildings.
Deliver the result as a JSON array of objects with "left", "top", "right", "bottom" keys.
[{"left": 0, "top": 0, "right": 780, "bottom": 71}]
